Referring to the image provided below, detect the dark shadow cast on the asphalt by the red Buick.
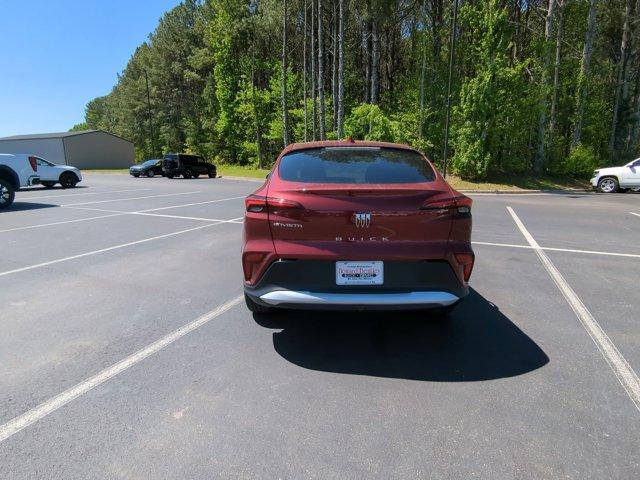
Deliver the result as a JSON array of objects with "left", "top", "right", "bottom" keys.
[{"left": 254, "top": 290, "right": 549, "bottom": 382}]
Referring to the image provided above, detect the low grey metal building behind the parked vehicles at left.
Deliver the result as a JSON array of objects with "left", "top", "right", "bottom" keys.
[{"left": 0, "top": 130, "right": 135, "bottom": 169}]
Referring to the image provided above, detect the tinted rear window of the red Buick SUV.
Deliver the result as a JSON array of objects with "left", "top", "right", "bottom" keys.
[{"left": 278, "top": 147, "right": 435, "bottom": 184}]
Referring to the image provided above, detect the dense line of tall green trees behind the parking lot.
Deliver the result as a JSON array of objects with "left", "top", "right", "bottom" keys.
[{"left": 74, "top": 0, "right": 640, "bottom": 178}]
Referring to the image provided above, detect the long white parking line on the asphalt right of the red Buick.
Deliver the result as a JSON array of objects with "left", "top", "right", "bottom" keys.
[{"left": 507, "top": 207, "right": 640, "bottom": 411}]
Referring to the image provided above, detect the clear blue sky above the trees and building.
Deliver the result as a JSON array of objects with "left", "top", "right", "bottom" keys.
[{"left": 0, "top": 0, "right": 179, "bottom": 137}]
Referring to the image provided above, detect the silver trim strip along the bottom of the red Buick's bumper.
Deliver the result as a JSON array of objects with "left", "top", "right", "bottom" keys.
[{"left": 260, "top": 290, "right": 460, "bottom": 307}]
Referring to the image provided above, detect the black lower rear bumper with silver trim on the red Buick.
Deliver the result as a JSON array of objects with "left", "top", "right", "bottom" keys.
[{"left": 245, "top": 260, "right": 469, "bottom": 310}]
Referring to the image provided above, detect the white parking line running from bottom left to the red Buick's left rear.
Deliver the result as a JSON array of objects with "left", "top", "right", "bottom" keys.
[{"left": 0, "top": 295, "right": 243, "bottom": 442}]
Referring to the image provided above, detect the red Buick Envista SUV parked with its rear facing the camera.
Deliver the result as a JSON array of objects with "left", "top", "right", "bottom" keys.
[{"left": 242, "top": 140, "right": 474, "bottom": 313}]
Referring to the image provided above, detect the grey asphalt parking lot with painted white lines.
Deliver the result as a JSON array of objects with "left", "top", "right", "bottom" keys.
[{"left": 0, "top": 174, "right": 640, "bottom": 479}]
